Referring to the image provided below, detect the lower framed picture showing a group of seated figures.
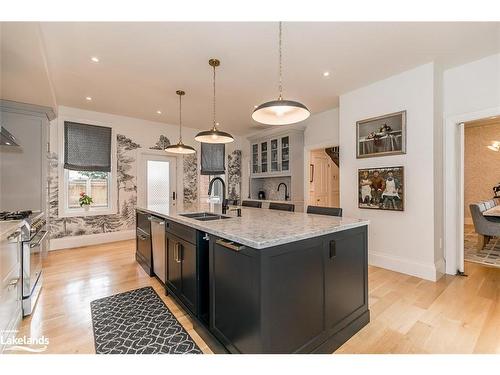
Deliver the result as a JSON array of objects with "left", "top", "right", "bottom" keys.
[{"left": 358, "top": 167, "right": 405, "bottom": 211}]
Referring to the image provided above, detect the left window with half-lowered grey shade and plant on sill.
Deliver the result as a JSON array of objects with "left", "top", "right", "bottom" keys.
[{"left": 59, "top": 121, "right": 117, "bottom": 217}]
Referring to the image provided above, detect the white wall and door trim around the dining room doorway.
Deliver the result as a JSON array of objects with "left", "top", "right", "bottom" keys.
[{"left": 442, "top": 54, "right": 500, "bottom": 274}]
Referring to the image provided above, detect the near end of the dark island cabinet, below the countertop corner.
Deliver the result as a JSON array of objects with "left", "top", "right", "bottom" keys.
[{"left": 210, "top": 226, "right": 369, "bottom": 353}]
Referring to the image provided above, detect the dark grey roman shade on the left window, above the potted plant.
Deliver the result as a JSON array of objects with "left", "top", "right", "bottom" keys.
[{"left": 64, "top": 121, "right": 111, "bottom": 172}]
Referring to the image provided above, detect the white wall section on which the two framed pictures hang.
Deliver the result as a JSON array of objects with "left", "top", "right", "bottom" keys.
[{"left": 339, "top": 63, "right": 442, "bottom": 280}]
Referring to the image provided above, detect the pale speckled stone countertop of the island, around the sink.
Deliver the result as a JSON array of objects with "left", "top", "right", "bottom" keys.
[{"left": 137, "top": 204, "right": 369, "bottom": 249}]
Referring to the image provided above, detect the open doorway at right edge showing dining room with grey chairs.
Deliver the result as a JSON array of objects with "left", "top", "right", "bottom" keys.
[{"left": 462, "top": 117, "right": 500, "bottom": 267}]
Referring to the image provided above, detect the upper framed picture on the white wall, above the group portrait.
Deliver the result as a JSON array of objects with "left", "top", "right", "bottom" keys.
[{"left": 356, "top": 111, "right": 406, "bottom": 159}]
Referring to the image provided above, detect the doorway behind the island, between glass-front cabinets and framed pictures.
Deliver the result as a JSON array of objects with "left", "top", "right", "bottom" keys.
[{"left": 307, "top": 146, "right": 340, "bottom": 207}]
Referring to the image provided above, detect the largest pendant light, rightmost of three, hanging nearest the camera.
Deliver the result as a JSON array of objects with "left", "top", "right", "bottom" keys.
[{"left": 252, "top": 22, "right": 311, "bottom": 125}]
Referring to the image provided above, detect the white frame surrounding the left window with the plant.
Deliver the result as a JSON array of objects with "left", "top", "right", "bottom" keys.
[{"left": 57, "top": 116, "right": 118, "bottom": 218}]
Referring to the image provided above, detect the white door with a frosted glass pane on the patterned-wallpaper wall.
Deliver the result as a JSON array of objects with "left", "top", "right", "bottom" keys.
[{"left": 137, "top": 150, "right": 177, "bottom": 211}]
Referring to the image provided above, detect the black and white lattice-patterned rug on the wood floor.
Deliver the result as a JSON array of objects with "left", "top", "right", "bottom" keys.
[{"left": 90, "top": 287, "right": 202, "bottom": 354}]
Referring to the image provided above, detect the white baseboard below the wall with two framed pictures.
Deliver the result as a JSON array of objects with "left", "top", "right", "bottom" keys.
[{"left": 368, "top": 251, "right": 444, "bottom": 281}]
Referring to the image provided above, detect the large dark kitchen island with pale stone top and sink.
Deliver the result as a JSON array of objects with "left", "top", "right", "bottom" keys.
[{"left": 137, "top": 205, "right": 369, "bottom": 353}]
